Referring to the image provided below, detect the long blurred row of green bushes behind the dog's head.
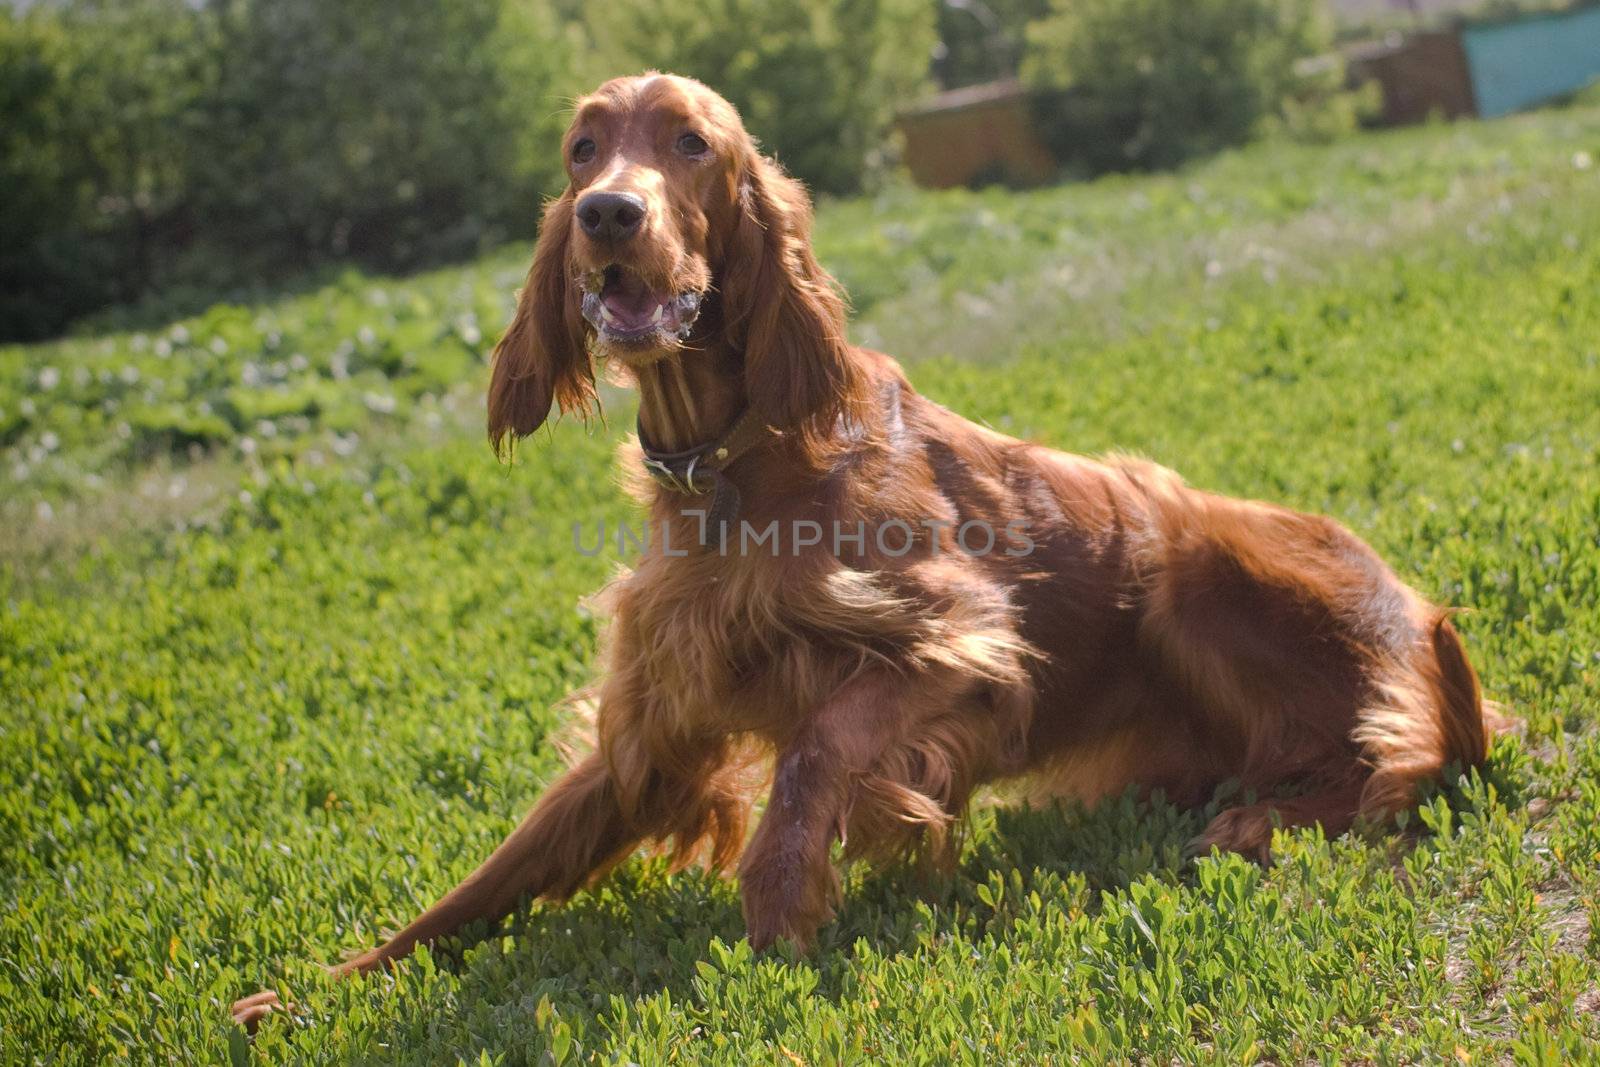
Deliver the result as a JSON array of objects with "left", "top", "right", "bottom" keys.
[{"left": 0, "top": 0, "right": 936, "bottom": 339}]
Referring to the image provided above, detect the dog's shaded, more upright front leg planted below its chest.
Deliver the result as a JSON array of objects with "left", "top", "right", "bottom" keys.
[{"left": 739, "top": 677, "right": 898, "bottom": 949}]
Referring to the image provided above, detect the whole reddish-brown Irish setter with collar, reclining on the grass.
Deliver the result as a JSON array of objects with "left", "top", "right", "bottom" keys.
[{"left": 235, "top": 74, "right": 1494, "bottom": 1024}]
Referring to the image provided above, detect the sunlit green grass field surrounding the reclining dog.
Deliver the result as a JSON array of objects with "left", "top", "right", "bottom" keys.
[{"left": 0, "top": 107, "right": 1600, "bottom": 1064}]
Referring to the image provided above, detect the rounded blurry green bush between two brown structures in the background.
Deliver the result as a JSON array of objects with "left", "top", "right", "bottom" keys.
[{"left": 1022, "top": 0, "right": 1355, "bottom": 171}]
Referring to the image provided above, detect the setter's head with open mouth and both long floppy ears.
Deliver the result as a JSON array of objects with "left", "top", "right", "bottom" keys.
[{"left": 488, "top": 74, "right": 858, "bottom": 450}]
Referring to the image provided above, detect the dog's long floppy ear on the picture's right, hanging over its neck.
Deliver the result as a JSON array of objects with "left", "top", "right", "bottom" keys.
[{"left": 722, "top": 147, "right": 866, "bottom": 437}]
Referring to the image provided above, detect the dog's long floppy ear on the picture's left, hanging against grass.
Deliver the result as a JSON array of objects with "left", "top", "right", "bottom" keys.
[{"left": 490, "top": 189, "right": 598, "bottom": 458}]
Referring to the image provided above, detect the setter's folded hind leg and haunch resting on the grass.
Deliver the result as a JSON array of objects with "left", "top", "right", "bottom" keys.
[{"left": 1141, "top": 498, "right": 1490, "bottom": 856}]
